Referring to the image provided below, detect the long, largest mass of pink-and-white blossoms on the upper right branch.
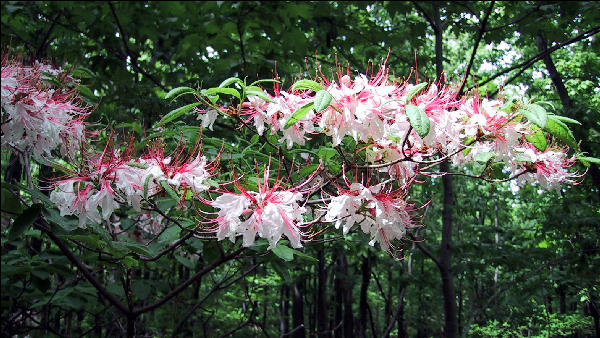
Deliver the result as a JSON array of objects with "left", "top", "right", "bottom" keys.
[{"left": 245, "top": 65, "right": 576, "bottom": 189}]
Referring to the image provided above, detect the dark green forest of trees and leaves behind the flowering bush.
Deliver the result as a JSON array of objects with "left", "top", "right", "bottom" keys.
[{"left": 1, "top": 1, "right": 600, "bottom": 337}]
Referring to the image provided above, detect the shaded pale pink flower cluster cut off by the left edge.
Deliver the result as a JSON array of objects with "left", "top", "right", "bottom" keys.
[{"left": 2, "top": 56, "right": 89, "bottom": 157}]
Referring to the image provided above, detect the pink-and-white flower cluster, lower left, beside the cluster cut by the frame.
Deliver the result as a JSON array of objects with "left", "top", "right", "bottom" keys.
[{"left": 50, "top": 142, "right": 218, "bottom": 226}]
